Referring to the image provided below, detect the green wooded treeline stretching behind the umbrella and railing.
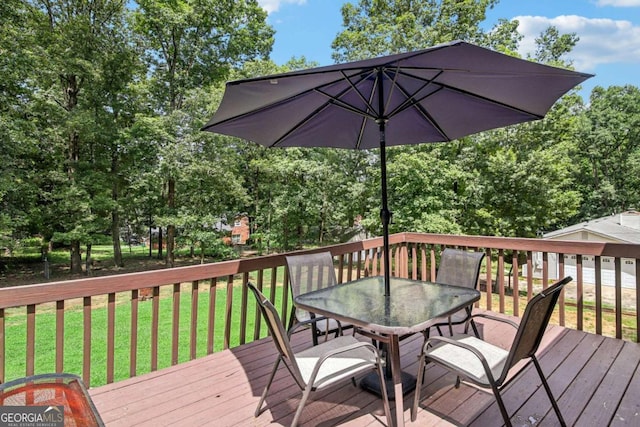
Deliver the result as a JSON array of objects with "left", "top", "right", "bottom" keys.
[{"left": 0, "top": 0, "right": 640, "bottom": 273}]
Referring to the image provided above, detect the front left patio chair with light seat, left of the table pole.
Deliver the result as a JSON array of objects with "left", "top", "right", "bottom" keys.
[{"left": 247, "top": 283, "right": 391, "bottom": 426}]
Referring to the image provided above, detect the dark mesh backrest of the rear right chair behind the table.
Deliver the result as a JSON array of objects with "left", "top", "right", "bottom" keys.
[{"left": 436, "top": 248, "right": 484, "bottom": 289}]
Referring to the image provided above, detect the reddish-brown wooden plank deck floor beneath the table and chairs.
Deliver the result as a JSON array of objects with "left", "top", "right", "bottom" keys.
[{"left": 91, "top": 310, "right": 640, "bottom": 427}]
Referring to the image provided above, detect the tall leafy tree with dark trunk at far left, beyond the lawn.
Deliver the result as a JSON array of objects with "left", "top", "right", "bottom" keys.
[{"left": 21, "top": 0, "right": 134, "bottom": 273}]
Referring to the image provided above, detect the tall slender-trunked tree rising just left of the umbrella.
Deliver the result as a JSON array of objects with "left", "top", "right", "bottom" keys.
[{"left": 134, "top": 0, "right": 273, "bottom": 266}]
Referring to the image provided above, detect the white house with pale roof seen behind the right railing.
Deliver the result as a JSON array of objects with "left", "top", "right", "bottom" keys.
[{"left": 523, "top": 210, "right": 640, "bottom": 288}]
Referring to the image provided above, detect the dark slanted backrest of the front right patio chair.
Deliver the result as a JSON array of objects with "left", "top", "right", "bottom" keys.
[{"left": 498, "top": 276, "right": 573, "bottom": 382}]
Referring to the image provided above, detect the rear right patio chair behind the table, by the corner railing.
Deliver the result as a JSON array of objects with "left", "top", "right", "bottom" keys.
[{"left": 424, "top": 248, "right": 484, "bottom": 340}]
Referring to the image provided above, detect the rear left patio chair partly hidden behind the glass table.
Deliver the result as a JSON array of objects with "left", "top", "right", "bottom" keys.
[{"left": 286, "top": 252, "right": 352, "bottom": 345}]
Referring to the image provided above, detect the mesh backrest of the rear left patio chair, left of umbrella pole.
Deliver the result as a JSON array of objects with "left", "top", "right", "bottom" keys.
[{"left": 286, "top": 252, "right": 338, "bottom": 321}]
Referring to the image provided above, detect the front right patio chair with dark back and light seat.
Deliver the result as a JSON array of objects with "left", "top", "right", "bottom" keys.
[{"left": 411, "top": 277, "right": 572, "bottom": 427}]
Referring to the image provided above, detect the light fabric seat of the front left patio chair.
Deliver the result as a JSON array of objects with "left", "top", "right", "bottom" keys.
[{"left": 295, "top": 335, "right": 376, "bottom": 388}]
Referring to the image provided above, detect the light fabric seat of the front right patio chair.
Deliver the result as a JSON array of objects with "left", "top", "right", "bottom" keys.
[{"left": 426, "top": 334, "right": 509, "bottom": 387}]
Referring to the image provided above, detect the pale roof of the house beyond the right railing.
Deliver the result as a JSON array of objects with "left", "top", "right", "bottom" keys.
[{"left": 543, "top": 211, "right": 640, "bottom": 243}]
